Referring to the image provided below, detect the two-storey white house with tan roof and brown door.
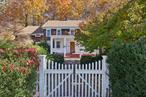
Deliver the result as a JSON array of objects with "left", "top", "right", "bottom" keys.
[{"left": 42, "top": 20, "right": 95, "bottom": 57}]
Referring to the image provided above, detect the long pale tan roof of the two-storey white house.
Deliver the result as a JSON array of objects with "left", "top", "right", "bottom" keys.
[{"left": 42, "top": 20, "right": 82, "bottom": 28}]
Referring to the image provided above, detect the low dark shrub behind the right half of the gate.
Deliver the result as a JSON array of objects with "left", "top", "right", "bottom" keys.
[{"left": 80, "top": 55, "right": 102, "bottom": 64}]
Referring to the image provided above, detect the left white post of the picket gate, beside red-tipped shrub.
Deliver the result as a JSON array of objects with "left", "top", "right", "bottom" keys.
[{"left": 38, "top": 55, "right": 47, "bottom": 97}]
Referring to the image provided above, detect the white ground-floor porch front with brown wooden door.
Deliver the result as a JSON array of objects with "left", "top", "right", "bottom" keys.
[{"left": 50, "top": 35, "right": 79, "bottom": 57}]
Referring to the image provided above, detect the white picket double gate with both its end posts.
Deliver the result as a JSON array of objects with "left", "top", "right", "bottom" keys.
[{"left": 37, "top": 55, "right": 109, "bottom": 97}]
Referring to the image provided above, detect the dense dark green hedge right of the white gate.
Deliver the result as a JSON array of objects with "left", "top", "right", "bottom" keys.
[{"left": 107, "top": 40, "right": 146, "bottom": 97}]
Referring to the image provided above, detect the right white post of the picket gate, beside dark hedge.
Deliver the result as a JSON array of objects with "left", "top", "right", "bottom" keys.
[{"left": 102, "top": 55, "right": 109, "bottom": 97}]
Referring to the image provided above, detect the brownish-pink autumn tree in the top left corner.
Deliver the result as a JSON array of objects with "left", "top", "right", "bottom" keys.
[{"left": 0, "top": 0, "right": 22, "bottom": 32}]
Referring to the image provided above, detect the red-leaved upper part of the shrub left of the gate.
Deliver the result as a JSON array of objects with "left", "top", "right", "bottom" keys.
[{"left": 0, "top": 48, "right": 39, "bottom": 74}]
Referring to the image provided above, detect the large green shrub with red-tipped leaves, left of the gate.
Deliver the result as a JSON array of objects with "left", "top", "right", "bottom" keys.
[{"left": 0, "top": 42, "right": 38, "bottom": 97}]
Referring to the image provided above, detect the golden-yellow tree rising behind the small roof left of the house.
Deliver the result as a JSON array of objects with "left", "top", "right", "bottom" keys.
[{"left": 22, "top": 0, "right": 48, "bottom": 25}]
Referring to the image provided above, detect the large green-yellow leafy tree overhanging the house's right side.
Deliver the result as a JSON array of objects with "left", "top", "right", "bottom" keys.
[{"left": 76, "top": 0, "right": 146, "bottom": 51}]
